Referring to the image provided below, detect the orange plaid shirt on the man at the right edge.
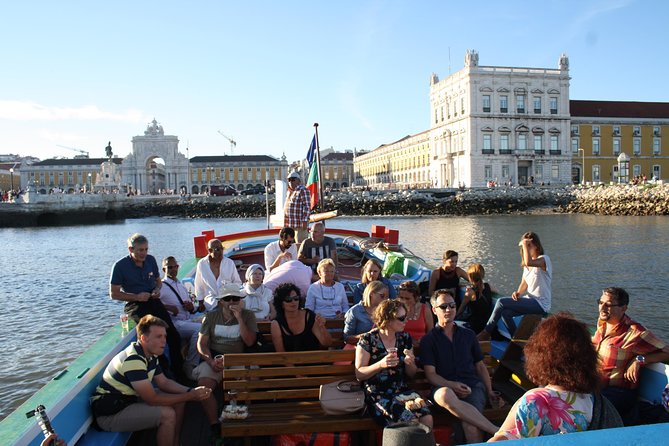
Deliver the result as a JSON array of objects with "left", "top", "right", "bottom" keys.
[{"left": 592, "top": 315, "right": 667, "bottom": 389}]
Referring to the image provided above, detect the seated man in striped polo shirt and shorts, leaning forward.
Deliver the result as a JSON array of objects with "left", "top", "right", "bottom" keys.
[{"left": 91, "top": 315, "right": 211, "bottom": 446}]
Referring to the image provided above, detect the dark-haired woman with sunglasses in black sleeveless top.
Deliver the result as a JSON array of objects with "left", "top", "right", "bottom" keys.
[{"left": 271, "top": 283, "right": 332, "bottom": 352}]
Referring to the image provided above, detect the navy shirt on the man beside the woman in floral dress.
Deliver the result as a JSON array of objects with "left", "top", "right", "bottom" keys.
[{"left": 420, "top": 325, "right": 483, "bottom": 387}]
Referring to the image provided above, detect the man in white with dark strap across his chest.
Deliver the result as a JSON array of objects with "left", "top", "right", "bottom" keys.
[{"left": 160, "top": 256, "right": 202, "bottom": 376}]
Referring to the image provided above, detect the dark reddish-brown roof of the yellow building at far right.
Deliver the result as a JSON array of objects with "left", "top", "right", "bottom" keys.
[{"left": 569, "top": 100, "right": 669, "bottom": 119}]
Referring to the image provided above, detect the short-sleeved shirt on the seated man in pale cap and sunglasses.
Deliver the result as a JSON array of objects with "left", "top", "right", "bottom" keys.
[{"left": 200, "top": 308, "right": 258, "bottom": 355}]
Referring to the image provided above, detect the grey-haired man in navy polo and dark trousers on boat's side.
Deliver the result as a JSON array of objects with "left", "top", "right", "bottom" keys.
[{"left": 109, "top": 234, "right": 184, "bottom": 381}]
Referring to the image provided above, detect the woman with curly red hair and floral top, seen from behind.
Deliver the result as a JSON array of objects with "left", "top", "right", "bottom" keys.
[{"left": 491, "top": 313, "right": 623, "bottom": 441}]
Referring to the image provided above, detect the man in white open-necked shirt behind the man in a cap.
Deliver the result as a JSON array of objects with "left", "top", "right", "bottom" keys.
[{"left": 195, "top": 238, "right": 242, "bottom": 311}]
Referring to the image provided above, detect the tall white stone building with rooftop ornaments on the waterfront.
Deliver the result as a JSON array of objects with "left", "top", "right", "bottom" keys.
[{"left": 430, "top": 50, "right": 571, "bottom": 187}]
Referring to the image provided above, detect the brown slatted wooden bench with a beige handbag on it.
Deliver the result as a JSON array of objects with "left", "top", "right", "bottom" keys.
[{"left": 221, "top": 343, "right": 511, "bottom": 442}]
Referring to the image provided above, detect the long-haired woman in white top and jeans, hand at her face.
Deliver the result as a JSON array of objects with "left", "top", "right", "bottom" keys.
[{"left": 478, "top": 232, "right": 553, "bottom": 341}]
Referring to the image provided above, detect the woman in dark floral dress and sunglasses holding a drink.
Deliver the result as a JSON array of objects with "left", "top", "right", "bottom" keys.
[{"left": 355, "top": 300, "right": 433, "bottom": 428}]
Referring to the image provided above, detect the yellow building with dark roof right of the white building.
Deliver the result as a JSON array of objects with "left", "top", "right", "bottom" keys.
[{"left": 569, "top": 100, "right": 669, "bottom": 183}]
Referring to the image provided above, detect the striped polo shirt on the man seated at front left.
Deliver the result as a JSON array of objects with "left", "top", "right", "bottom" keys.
[{"left": 94, "top": 342, "right": 163, "bottom": 398}]
